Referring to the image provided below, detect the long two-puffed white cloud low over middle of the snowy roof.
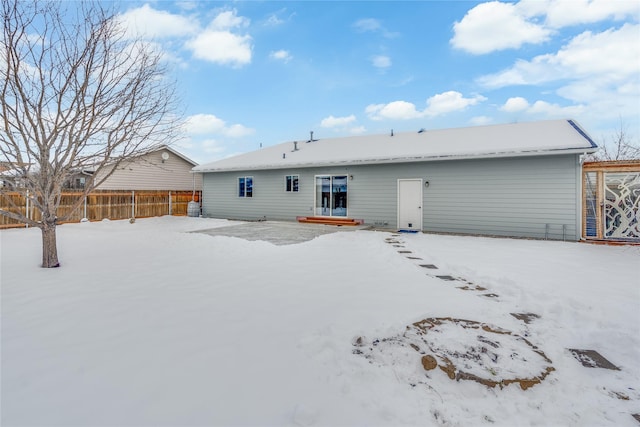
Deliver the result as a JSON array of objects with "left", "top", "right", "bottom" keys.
[{"left": 365, "top": 91, "right": 486, "bottom": 120}]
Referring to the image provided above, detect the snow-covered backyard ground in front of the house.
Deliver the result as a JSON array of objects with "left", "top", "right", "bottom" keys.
[{"left": 0, "top": 217, "right": 640, "bottom": 426}]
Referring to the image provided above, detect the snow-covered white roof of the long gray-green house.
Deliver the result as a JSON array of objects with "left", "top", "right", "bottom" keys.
[{"left": 193, "top": 120, "right": 597, "bottom": 172}]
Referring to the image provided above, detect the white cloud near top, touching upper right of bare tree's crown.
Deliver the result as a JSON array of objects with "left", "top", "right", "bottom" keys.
[{"left": 118, "top": 4, "right": 198, "bottom": 39}]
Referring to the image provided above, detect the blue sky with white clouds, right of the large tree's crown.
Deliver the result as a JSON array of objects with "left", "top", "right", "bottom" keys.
[{"left": 120, "top": 0, "right": 640, "bottom": 163}]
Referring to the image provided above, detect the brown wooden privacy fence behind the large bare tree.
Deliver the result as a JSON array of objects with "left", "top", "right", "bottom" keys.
[{"left": 0, "top": 190, "right": 202, "bottom": 228}]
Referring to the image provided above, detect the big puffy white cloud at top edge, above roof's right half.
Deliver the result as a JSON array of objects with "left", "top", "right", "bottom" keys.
[{"left": 450, "top": 1, "right": 551, "bottom": 55}]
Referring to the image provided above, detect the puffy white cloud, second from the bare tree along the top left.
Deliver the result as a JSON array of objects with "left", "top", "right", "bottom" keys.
[{"left": 186, "top": 10, "right": 252, "bottom": 67}]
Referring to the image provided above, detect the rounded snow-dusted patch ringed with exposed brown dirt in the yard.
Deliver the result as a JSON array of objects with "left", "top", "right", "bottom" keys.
[{"left": 354, "top": 317, "right": 555, "bottom": 390}]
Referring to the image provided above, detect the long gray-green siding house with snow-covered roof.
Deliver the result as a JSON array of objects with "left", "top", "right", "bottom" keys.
[{"left": 193, "top": 120, "right": 597, "bottom": 240}]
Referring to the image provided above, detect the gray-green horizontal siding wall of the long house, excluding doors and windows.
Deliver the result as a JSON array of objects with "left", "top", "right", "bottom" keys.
[{"left": 203, "top": 155, "right": 580, "bottom": 240}]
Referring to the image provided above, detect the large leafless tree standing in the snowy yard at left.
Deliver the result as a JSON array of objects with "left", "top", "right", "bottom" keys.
[{"left": 0, "top": 0, "right": 179, "bottom": 267}]
